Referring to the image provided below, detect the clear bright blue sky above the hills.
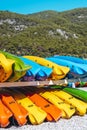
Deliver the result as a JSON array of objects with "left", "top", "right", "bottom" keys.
[{"left": 0, "top": 0, "right": 87, "bottom": 14}]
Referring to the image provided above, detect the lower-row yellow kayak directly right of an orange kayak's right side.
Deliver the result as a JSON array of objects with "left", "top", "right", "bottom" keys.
[{"left": 40, "top": 91, "right": 75, "bottom": 118}]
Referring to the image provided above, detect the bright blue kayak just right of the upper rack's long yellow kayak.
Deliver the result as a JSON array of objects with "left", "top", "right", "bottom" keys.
[{"left": 46, "top": 57, "right": 87, "bottom": 76}]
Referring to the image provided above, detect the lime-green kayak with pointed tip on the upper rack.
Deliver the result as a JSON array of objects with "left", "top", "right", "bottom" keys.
[{"left": 0, "top": 51, "right": 31, "bottom": 82}]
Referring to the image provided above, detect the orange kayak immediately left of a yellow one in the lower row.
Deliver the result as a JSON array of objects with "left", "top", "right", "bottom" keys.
[{"left": 1, "top": 94, "right": 28, "bottom": 126}]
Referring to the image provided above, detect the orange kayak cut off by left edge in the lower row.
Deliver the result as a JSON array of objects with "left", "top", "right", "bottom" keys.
[{"left": 0, "top": 100, "right": 12, "bottom": 127}]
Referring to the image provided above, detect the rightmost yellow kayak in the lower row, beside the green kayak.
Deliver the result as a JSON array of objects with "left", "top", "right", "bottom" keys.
[{"left": 53, "top": 90, "right": 87, "bottom": 115}]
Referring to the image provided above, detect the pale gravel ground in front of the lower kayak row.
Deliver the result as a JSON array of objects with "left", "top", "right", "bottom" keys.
[{"left": 0, "top": 87, "right": 87, "bottom": 130}]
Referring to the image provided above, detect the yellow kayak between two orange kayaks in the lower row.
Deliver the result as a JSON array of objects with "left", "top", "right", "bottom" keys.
[{"left": 9, "top": 91, "right": 47, "bottom": 125}]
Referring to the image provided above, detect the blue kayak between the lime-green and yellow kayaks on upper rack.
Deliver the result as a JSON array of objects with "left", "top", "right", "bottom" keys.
[{"left": 20, "top": 57, "right": 52, "bottom": 81}]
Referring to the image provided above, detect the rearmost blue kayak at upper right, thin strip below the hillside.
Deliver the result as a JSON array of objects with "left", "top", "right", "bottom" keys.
[{"left": 54, "top": 55, "right": 87, "bottom": 64}]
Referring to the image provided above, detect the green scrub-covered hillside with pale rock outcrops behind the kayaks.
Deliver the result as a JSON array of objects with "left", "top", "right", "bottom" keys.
[{"left": 0, "top": 8, "right": 87, "bottom": 58}]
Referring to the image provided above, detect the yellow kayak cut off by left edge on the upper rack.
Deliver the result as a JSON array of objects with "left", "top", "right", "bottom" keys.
[{"left": 0, "top": 53, "right": 15, "bottom": 82}]
